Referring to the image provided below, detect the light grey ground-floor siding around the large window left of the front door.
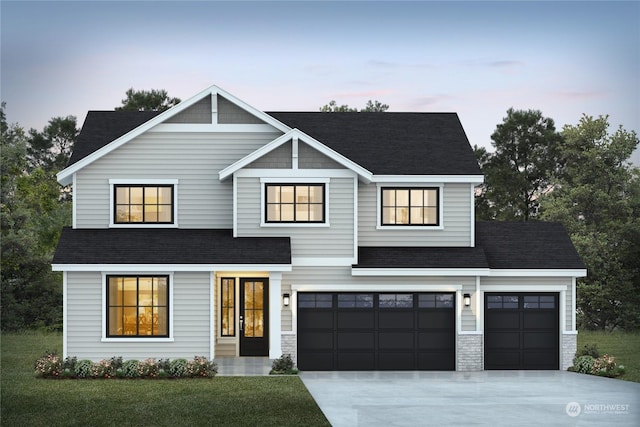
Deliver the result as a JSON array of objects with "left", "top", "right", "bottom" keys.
[{"left": 66, "top": 272, "right": 211, "bottom": 361}]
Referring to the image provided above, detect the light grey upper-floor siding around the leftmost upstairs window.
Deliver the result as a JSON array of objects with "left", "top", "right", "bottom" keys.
[{"left": 74, "top": 132, "right": 279, "bottom": 228}]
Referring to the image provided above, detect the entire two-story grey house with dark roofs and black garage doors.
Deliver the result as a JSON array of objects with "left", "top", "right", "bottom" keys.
[{"left": 53, "top": 86, "right": 586, "bottom": 370}]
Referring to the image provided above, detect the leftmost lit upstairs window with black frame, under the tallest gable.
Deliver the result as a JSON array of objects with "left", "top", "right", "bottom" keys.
[{"left": 113, "top": 184, "right": 174, "bottom": 224}]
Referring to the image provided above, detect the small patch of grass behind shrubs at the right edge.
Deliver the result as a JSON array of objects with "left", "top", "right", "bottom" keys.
[{"left": 578, "top": 331, "right": 640, "bottom": 382}]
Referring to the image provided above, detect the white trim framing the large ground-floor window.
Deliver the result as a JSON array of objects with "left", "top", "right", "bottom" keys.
[{"left": 100, "top": 271, "right": 174, "bottom": 343}]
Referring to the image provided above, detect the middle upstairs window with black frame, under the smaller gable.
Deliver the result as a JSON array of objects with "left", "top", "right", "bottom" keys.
[{"left": 265, "top": 184, "right": 325, "bottom": 223}]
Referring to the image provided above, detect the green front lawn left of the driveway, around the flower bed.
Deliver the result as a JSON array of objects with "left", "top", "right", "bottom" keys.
[{"left": 1, "top": 333, "right": 329, "bottom": 427}]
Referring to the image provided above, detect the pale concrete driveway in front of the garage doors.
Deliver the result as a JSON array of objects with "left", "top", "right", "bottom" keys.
[{"left": 301, "top": 371, "right": 640, "bottom": 427}]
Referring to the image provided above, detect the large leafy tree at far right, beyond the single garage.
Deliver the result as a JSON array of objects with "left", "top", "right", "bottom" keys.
[{"left": 541, "top": 115, "right": 640, "bottom": 330}]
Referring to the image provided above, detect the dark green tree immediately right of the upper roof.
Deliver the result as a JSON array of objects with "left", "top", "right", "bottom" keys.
[{"left": 476, "top": 108, "right": 561, "bottom": 221}]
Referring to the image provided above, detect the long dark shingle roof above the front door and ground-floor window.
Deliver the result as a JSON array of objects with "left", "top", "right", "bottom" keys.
[{"left": 52, "top": 227, "right": 291, "bottom": 264}]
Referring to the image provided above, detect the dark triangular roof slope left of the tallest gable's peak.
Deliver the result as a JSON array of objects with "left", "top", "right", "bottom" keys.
[{"left": 68, "top": 111, "right": 160, "bottom": 166}]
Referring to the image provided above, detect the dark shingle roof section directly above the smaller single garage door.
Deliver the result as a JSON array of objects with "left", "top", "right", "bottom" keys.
[{"left": 476, "top": 221, "right": 585, "bottom": 269}]
